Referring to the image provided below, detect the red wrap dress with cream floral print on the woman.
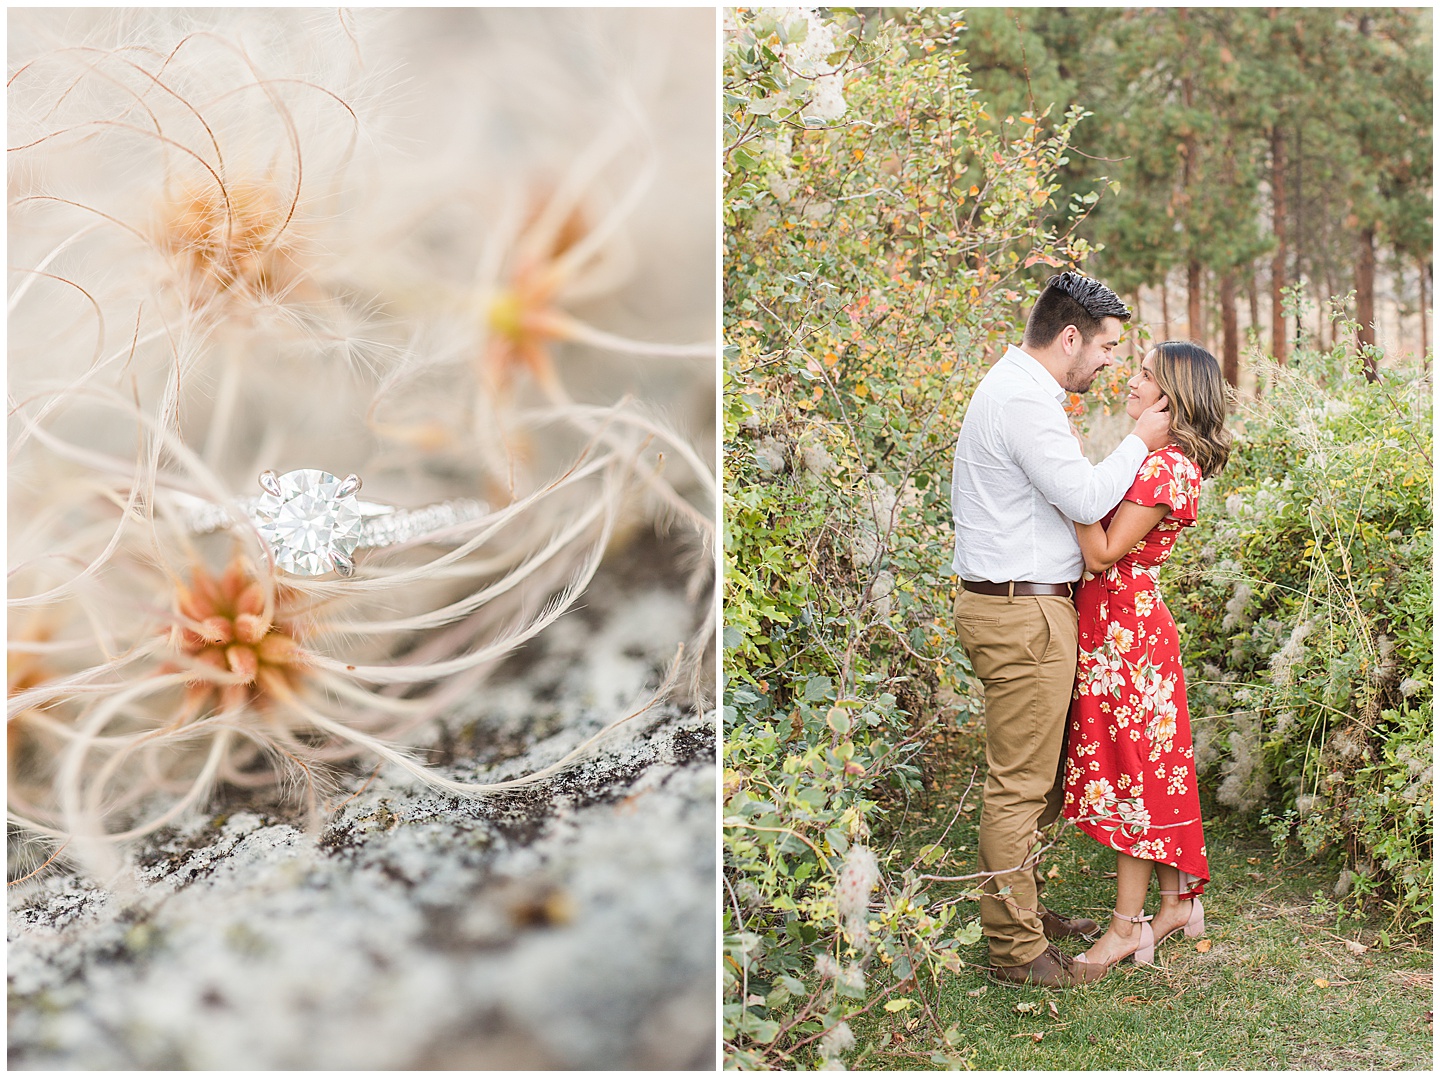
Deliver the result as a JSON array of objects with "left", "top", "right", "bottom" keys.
[{"left": 1064, "top": 445, "right": 1210, "bottom": 897}]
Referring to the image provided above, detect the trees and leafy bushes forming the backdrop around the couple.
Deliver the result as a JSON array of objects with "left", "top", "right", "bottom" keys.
[{"left": 723, "top": 9, "right": 1433, "bottom": 1066}]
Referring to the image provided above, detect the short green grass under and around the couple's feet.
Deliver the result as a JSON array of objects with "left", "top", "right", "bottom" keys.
[{"left": 847, "top": 727, "right": 1433, "bottom": 1071}]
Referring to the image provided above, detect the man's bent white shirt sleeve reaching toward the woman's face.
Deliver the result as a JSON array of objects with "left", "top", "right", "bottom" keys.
[{"left": 1005, "top": 390, "right": 1149, "bottom": 524}]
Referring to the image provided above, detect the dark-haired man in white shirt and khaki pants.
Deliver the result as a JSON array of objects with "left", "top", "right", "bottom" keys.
[{"left": 950, "top": 273, "right": 1169, "bottom": 987}]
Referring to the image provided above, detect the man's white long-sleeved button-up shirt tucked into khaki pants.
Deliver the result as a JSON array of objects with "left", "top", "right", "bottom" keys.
[{"left": 950, "top": 345, "right": 1149, "bottom": 584}]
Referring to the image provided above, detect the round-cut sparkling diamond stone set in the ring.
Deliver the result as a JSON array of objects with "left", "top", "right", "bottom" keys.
[{"left": 253, "top": 468, "right": 360, "bottom": 576}]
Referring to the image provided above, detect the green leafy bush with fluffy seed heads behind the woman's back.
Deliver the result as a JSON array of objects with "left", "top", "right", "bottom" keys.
[{"left": 1166, "top": 325, "right": 1433, "bottom": 927}]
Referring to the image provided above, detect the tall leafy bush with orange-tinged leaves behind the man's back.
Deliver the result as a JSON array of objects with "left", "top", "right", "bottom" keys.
[{"left": 723, "top": 10, "right": 1093, "bottom": 1066}]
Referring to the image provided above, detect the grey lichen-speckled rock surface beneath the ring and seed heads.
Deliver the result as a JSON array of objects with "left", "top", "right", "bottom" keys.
[{"left": 9, "top": 549, "right": 717, "bottom": 1069}]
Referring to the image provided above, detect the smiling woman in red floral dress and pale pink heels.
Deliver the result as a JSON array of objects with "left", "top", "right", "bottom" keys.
[{"left": 1064, "top": 341, "right": 1230, "bottom": 966}]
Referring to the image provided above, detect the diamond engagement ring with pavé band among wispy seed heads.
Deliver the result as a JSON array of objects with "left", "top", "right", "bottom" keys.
[{"left": 179, "top": 468, "right": 490, "bottom": 577}]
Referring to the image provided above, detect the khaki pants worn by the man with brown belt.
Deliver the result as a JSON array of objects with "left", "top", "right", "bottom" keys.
[{"left": 955, "top": 589, "right": 1079, "bottom": 966}]
